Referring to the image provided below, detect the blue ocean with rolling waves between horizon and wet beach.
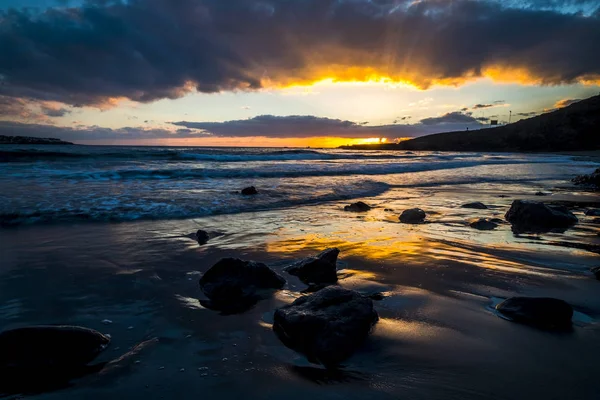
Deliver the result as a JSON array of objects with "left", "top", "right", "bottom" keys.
[{"left": 0, "top": 145, "right": 595, "bottom": 225}]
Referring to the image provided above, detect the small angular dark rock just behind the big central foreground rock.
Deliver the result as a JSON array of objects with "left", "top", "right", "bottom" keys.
[{"left": 285, "top": 248, "right": 340, "bottom": 285}]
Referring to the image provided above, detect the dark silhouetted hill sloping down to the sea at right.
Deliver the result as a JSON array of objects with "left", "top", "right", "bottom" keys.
[{"left": 346, "top": 96, "right": 600, "bottom": 152}]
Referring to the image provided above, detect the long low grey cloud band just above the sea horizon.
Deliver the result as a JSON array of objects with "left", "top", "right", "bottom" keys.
[{"left": 0, "top": 112, "right": 482, "bottom": 142}]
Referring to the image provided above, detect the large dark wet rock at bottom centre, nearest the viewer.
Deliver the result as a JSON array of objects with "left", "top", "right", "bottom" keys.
[{"left": 273, "top": 286, "right": 379, "bottom": 368}]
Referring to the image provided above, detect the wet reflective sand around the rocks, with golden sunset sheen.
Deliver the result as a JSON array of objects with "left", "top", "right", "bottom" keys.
[{"left": 0, "top": 184, "right": 600, "bottom": 400}]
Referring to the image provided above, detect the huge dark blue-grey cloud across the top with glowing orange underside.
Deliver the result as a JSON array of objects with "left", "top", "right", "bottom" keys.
[{"left": 0, "top": 0, "right": 600, "bottom": 111}]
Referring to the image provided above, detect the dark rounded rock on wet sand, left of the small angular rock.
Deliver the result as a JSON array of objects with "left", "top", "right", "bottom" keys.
[{"left": 199, "top": 258, "right": 285, "bottom": 313}]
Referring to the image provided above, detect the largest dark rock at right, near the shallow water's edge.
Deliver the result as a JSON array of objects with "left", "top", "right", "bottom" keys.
[{"left": 506, "top": 200, "right": 578, "bottom": 233}]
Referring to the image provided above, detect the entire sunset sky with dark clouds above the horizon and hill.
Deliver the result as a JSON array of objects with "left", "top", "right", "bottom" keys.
[{"left": 0, "top": 0, "right": 600, "bottom": 147}]
